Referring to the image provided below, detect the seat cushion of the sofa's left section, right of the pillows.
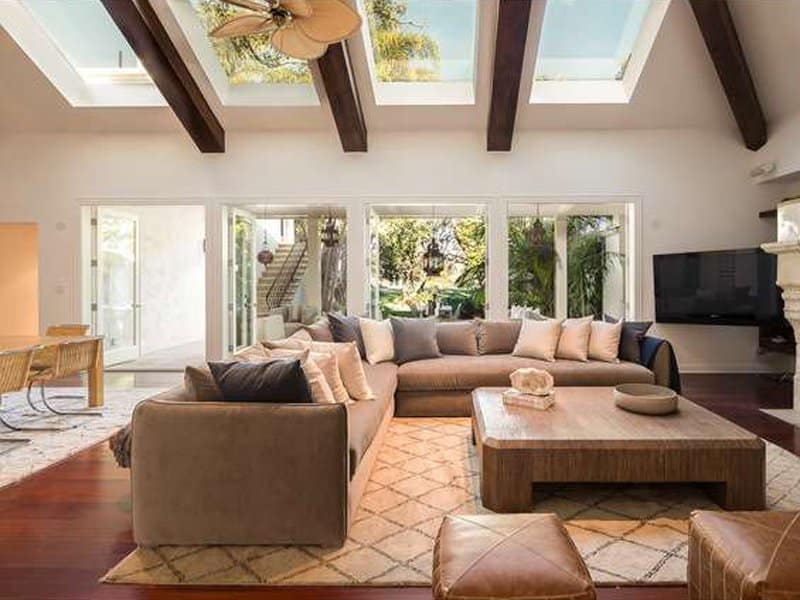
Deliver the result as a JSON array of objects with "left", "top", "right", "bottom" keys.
[{"left": 347, "top": 362, "right": 397, "bottom": 479}]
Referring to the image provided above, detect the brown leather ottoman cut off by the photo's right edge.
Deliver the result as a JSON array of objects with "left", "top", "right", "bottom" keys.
[{"left": 688, "top": 511, "right": 800, "bottom": 600}]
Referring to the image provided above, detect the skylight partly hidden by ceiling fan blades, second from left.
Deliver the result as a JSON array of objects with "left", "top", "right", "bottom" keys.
[{"left": 168, "top": 0, "right": 319, "bottom": 106}]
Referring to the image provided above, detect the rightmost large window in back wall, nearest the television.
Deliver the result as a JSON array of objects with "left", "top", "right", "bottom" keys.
[{"left": 508, "top": 203, "right": 633, "bottom": 318}]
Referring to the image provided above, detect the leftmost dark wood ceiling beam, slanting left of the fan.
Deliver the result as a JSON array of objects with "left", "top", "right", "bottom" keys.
[{"left": 102, "top": 0, "right": 225, "bottom": 152}]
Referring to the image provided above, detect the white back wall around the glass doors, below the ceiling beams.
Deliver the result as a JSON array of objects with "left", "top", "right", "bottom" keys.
[{"left": 0, "top": 130, "right": 785, "bottom": 371}]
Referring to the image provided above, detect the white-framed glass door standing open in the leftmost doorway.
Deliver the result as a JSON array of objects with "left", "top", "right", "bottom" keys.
[{"left": 95, "top": 209, "right": 140, "bottom": 364}]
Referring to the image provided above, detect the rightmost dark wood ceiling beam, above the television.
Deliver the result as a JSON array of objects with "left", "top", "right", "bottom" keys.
[{"left": 691, "top": 0, "right": 767, "bottom": 150}]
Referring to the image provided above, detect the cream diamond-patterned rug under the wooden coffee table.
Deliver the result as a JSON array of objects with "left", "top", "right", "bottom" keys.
[{"left": 103, "top": 418, "right": 800, "bottom": 586}]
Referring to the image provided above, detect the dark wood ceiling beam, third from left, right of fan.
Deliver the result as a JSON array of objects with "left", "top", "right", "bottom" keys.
[{"left": 486, "top": 0, "right": 531, "bottom": 152}]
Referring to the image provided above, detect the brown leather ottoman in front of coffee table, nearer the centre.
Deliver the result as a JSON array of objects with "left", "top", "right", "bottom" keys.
[{"left": 433, "top": 514, "right": 596, "bottom": 600}]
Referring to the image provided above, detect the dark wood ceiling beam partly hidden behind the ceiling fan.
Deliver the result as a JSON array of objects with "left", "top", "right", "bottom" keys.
[{"left": 317, "top": 42, "right": 367, "bottom": 152}]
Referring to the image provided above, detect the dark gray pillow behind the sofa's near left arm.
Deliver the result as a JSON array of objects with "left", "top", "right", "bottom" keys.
[{"left": 208, "top": 358, "right": 312, "bottom": 404}]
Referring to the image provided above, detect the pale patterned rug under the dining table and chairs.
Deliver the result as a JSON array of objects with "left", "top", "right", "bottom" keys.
[{"left": 0, "top": 388, "right": 162, "bottom": 488}]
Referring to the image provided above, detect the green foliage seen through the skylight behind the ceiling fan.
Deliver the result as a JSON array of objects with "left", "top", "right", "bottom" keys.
[{"left": 196, "top": 0, "right": 311, "bottom": 85}]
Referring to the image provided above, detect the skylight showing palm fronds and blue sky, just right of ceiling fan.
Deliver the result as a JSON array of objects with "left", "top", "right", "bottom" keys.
[{"left": 362, "top": 0, "right": 478, "bottom": 104}]
